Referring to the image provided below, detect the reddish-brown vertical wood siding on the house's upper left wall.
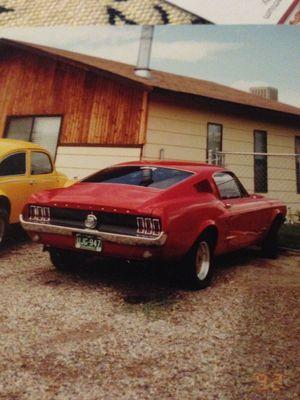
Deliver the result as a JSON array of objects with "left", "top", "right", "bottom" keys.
[{"left": 0, "top": 49, "right": 147, "bottom": 145}]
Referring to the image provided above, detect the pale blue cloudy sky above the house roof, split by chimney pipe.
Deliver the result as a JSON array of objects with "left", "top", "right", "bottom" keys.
[{"left": 0, "top": 25, "right": 300, "bottom": 107}]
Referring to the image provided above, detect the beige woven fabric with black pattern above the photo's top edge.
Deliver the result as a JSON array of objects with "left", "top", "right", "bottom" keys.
[{"left": 0, "top": 0, "right": 207, "bottom": 28}]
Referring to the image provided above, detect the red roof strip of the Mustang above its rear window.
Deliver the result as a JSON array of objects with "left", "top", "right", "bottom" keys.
[{"left": 118, "top": 160, "right": 224, "bottom": 174}]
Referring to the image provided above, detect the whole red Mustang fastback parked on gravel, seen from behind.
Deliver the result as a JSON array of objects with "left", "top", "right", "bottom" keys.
[{"left": 21, "top": 161, "right": 286, "bottom": 288}]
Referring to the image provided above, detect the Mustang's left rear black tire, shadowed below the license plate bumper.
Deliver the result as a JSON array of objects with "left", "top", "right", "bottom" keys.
[{"left": 48, "top": 248, "right": 86, "bottom": 272}]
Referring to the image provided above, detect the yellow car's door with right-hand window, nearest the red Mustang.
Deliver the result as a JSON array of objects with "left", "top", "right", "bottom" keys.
[{"left": 29, "top": 150, "right": 66, "bottom": 194}]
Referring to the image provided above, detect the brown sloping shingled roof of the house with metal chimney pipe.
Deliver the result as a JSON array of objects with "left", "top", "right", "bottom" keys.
[{"left": 0, "top": 39, "right": 300, "bottom": 117}]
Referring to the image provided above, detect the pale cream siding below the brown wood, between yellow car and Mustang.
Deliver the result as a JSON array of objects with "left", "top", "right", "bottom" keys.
[{"left": 55, "top": 146, "right": 141, "bottom": 178}]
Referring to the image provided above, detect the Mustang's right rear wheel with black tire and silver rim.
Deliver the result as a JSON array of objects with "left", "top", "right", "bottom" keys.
[{"left": 183, "top": 233, "right": 215, "bottom": 290}]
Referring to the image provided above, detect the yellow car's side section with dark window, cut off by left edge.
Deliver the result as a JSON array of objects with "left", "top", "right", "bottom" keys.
[{"left": 0, "top": 150, "right": 30, "bottom": 224}]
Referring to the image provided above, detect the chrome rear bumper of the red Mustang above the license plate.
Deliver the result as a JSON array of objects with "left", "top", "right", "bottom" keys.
[{"left": 20, "top": 215, "right": 167, "bottom": 247}]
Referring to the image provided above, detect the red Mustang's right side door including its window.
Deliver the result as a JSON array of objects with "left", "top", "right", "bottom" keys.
[{"left": 214, "top": 172, "right": 270, "bottom": 250}]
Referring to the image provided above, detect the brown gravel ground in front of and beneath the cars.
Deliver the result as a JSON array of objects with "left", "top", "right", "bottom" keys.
[{"left": 0, "top": 234, "right": 300, "bottom": 400}]
